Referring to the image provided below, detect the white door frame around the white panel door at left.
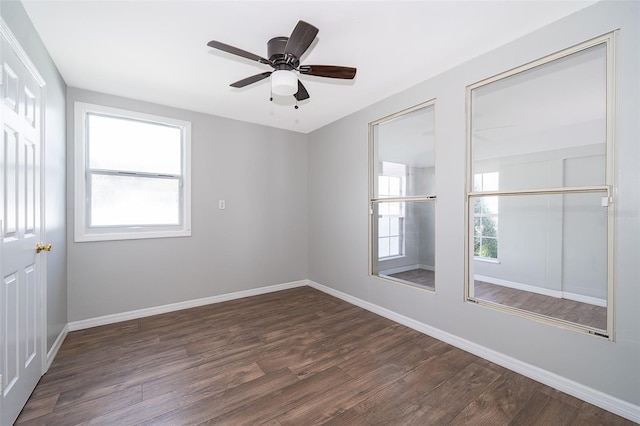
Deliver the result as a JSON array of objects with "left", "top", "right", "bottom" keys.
[{"left": 0, "top": 16, "right": 48, "bottom": 380}]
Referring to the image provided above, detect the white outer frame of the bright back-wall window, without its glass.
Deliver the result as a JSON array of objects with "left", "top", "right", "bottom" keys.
[{"left": 74, "top": 102, "right": 191, "bottom": 242}]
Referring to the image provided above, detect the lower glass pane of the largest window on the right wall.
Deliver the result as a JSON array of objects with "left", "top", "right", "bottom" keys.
[{"left": 469, "top": 191, "right": 608, "bottom": 330}]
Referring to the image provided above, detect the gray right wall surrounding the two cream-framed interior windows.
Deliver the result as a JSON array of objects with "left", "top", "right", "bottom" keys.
[{"left": 309, "top": 1, "right": 640, "bottom": 404}]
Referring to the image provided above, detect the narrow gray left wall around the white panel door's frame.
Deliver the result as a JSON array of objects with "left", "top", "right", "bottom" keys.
[{"left": 0, "top": 0, "right": 67, "bottom": 350}]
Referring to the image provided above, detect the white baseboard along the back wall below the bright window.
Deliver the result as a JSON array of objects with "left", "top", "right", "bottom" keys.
[{"left": 68, "top": 280, "right": 307, "bottom": 331}]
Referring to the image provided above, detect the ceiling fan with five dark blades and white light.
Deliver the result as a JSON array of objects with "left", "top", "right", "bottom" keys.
[{"left": 207, "top": 21, "right": 356, "bottom": 109}]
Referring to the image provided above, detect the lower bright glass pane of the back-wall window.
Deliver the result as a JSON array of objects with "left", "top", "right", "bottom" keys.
[{"left": 90, "top": 174, "right": 180, "bottom": 226}]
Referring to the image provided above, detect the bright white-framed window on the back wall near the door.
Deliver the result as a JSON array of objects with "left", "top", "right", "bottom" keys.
[{"left": 75, "top": 102, "right": 191, "bottom": 241}]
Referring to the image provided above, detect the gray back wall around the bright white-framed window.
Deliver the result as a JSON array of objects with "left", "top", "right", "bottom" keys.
[{"left": 67, "top": 88, "right": 308, "bottom": 321}]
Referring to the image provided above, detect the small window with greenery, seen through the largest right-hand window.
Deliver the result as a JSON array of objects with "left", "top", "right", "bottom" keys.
[{"left": 473, "top": 172, "right": 498, "bottom": 260}]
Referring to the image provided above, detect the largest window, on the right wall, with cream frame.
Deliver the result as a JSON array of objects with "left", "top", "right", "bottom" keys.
[{"left": 465, "top": 33, "right": 615, "bottom": 338}]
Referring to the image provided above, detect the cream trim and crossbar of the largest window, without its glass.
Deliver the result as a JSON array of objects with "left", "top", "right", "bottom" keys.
[{"left": 464, "top": 30, "right": 619, "bottom": 341}]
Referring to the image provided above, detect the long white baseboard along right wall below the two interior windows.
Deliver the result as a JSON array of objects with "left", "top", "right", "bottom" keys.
[{"left": 307, "top": 280, "right": 640, "bottom": 423}]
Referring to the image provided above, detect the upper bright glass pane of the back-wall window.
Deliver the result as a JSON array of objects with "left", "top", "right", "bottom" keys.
[{"left": 87, "top": 114, "right": 182, "bottom": 175}]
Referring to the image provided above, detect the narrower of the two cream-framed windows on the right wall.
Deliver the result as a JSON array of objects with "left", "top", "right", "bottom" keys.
[{"left": 369, "top": 102, "right": 436, "bottom": 290}]
